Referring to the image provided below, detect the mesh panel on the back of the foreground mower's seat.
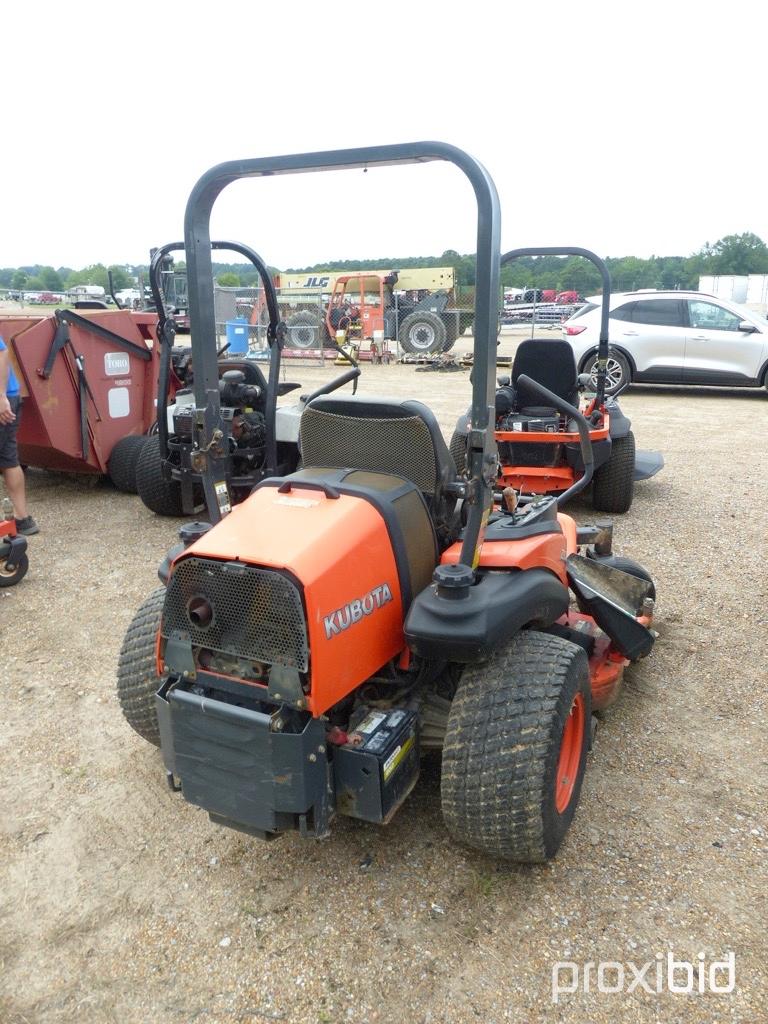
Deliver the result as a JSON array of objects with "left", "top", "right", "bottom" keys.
[{"left": 301, "top": 408, "right": 437, "bottom": 495}]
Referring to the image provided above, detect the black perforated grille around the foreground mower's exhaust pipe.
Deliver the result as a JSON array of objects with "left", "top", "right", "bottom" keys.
[{"left": 162, "top": 558, "right": 309, "bottom": 672}]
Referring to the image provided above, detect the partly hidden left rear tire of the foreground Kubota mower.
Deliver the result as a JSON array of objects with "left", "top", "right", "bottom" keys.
[{"left": 117, "top": 587, "right": 165, "bottom": 746}]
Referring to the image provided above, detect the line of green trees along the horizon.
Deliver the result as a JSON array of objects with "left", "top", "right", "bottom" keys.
[{"left": 6, "top": 231, "right": 768, "bottom": 295}]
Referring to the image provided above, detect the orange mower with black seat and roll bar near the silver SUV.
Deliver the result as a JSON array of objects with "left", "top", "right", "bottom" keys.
[{"left": 451, "top": 248, "right": 664, "bottom": 512}]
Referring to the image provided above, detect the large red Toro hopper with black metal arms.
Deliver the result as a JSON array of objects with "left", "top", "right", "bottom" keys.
[{"left": 0, "top": 309, "right": 175, "bottom": 490}]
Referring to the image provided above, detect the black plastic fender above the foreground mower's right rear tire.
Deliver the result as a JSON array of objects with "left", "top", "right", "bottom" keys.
[{"left": 404, "top": 569, "right": 568, "bottom": 663}]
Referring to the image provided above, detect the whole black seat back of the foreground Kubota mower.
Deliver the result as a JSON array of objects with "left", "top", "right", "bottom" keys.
[{"left": 299, "top": 395, "right": 457, "bottom": 540}]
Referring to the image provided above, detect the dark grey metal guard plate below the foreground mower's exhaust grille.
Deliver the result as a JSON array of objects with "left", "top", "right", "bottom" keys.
[{"left": 157, "top": 683, "right": 331, "bottom": 838}]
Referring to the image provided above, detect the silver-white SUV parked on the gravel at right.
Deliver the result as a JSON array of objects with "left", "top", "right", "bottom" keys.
[{"left": 563, "top": 292, "right": 768, "bottom": 394}]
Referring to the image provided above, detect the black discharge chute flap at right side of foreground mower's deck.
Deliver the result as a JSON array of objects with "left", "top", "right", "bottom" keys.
[{"left": 565, "top": 555, "right": 654, "bottom": 662}]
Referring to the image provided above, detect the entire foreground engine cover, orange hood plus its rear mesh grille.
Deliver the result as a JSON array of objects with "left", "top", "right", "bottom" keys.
[{"left": 161, "top": 470, "right": 433, "bottom": 716}]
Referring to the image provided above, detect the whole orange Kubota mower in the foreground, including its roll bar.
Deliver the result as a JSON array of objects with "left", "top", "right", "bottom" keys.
[{"left": 118, "top": 142, "right": 654, "bottom": 861}]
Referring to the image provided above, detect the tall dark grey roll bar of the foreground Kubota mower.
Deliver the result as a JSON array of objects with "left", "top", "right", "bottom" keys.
[{"left": 184, "top": 141, "right": 501, "bottom": 568}]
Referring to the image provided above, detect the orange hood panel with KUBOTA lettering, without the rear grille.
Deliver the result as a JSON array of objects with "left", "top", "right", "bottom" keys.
[{"left": 180, "top": 486, "right": 404, "bottom": 717}]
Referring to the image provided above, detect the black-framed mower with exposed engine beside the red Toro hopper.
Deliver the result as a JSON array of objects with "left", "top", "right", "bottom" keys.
[{"left": 136, "top": 242, "right": 359, "bottom": 512}]
